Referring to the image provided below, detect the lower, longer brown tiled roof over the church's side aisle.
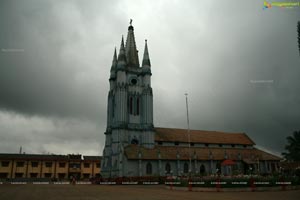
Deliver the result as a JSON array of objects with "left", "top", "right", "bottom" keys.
[{"left": 125, "top": 145, "right": 281, "bottom": 163}]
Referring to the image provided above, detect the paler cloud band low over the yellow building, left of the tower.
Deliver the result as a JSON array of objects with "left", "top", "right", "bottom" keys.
[{"left": 0, "top": 112, "right": 104, "bottom": 155}]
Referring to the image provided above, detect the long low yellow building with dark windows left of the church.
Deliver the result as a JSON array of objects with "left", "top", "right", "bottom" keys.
[{"left": 0, "top": 153, "right": 101, "bottom": 180}]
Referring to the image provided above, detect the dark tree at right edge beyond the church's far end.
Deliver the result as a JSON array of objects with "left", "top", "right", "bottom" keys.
[{"left": 282, "top": 131, "right": 300, "bottom": 161}]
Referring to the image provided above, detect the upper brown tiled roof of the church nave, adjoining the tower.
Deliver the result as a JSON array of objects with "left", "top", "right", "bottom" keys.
[{"left": 155, "top": 128, "right": 255, "bottom": 145}]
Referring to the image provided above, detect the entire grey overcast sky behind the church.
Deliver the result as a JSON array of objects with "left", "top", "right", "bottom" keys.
[{"left": 0, "top": 0, "right": 300, "bottom": 155}]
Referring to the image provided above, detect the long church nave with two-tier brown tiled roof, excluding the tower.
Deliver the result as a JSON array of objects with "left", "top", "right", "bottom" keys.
[{"left": 123, "top": 128, "right": 281, "bottom": 176}]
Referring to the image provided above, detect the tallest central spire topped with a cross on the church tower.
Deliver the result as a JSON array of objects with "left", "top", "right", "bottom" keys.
[{"left": 126, "top": 19, "right": 140, "bottom": 68}]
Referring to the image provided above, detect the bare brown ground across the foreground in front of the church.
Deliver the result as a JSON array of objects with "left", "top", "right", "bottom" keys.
[{"left": 0, "top": 184, "right": 300, "bottom": 200}]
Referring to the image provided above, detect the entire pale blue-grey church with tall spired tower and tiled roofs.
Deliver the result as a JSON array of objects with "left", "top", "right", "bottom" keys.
[{"left": 101, "top": 23, "right": 281, "bottom": 177}]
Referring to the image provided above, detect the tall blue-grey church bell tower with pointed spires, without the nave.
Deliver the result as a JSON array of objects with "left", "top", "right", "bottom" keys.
[{"left": 102, "top": 20, "right": 154, "bottom": 177}]
